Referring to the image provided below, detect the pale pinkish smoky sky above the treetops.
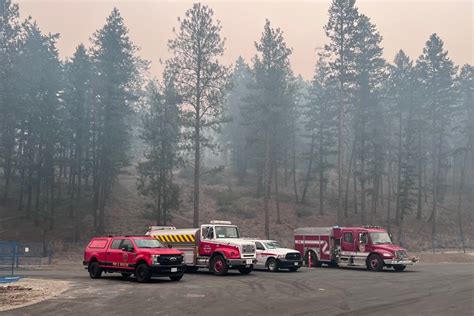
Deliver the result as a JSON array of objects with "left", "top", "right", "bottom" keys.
[{"left": 14, "top": 0, "right": 474, "bottom": 79}]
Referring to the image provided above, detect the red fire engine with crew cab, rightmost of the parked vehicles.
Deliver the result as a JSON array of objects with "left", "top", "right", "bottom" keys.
[{"left": 294, "top": 226, "right": 418, "bottom": 271}]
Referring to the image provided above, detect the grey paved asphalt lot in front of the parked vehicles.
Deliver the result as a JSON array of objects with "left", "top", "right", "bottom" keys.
[{"left": 4, "top": 264, "right": 474, "bottom": 316}]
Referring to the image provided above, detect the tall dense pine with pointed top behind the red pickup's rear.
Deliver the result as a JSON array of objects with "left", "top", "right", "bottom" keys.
[{"left": 92, "top": 8, "right": 146, "bottom": 232}]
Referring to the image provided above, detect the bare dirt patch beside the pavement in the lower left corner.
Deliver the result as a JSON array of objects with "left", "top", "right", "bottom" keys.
[{"left": 0, "top": 278, "right": 69, "bottom": 311}]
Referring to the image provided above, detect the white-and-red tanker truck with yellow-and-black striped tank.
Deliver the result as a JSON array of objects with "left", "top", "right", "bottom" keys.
[{"left": 146, "top": 221, "right": 256, "bottom": 275}]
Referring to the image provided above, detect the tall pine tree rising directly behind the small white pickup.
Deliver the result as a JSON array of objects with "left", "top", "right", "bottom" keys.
[{"left": 249, "top": 20, "right": 294, "bottom": 238}]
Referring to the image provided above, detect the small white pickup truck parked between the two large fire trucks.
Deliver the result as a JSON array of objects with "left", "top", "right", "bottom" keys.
[{"left": 253, "top": 239, "right": 303, "bottom": 272}]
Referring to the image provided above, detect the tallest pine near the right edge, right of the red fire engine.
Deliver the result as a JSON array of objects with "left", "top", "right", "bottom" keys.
[{"left": 417, "top": 34, "right": 455, "bottom": 252}]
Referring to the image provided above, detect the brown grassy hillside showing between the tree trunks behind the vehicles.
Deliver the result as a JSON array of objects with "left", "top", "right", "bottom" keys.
[{"left": 0, "top": 163, "right": 474, "bottom": 251}]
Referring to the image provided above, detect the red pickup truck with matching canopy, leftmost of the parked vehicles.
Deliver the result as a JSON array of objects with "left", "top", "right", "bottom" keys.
[{"left": 83, "top": 236, "right": 185, "bottom": 282}]
